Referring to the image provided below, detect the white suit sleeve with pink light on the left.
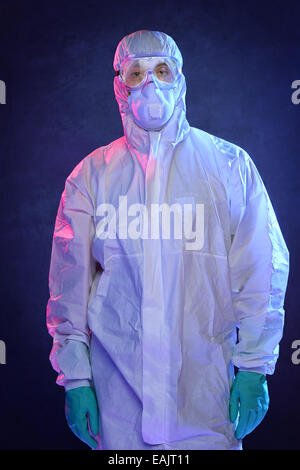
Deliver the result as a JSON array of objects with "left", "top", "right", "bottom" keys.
[{"left": 47, "top": 168, "right": 96, "bottom": 390}]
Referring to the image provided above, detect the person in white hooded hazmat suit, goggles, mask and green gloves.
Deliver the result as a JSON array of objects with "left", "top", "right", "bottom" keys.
[{"left": 47, "top": 30, "right": 289, "bottom": 450}]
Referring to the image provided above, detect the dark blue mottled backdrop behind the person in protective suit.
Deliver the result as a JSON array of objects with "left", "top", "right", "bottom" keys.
[{"left": 0, "top": 0, "right": 300, "bottom": 449}]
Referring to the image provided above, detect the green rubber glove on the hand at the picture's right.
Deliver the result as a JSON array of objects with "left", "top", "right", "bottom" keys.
[{"left": 229, "top": 371, "right": 269, "bottom": 439}]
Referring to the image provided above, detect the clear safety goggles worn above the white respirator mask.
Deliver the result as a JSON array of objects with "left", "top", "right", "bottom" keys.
[{"left": 117, "top": 56, "right": 181, "bottom": 88}]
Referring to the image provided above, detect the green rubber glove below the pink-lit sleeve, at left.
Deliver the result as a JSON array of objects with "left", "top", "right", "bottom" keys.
[{"left": 65, "top": 387, "right": 99, "bottom": 449}]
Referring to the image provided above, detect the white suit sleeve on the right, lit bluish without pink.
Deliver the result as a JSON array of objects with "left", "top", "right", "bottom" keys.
[{"left": 229, "top": 151, "right": 289, "bottom": 374}]
